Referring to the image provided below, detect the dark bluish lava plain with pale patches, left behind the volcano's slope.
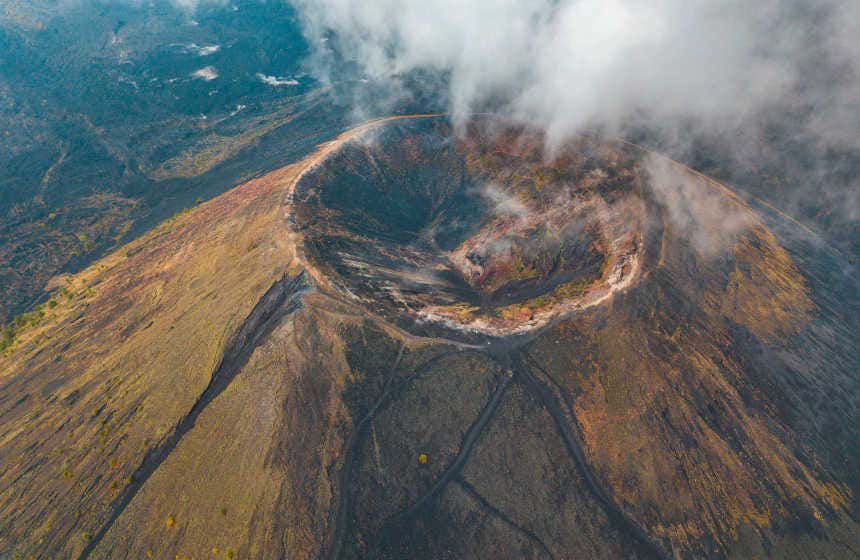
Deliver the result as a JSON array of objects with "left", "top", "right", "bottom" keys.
[{"left": 0, "top": 0, "right": 346, "bottom": 325}]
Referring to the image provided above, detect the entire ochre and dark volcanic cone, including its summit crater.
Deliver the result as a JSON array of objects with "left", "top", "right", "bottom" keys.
[{"left": 0, "top": 116, "right": 860, "bottom": 559}]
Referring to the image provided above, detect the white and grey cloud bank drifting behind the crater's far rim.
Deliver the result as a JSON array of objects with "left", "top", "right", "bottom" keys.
[{"left": 295, "top": 0, "right": 860, "bottom": 249}]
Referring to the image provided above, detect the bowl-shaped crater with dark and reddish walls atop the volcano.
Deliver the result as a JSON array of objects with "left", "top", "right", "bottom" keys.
[{"left": 294, "top": 118, "right": 645, "bottom": 336}]
